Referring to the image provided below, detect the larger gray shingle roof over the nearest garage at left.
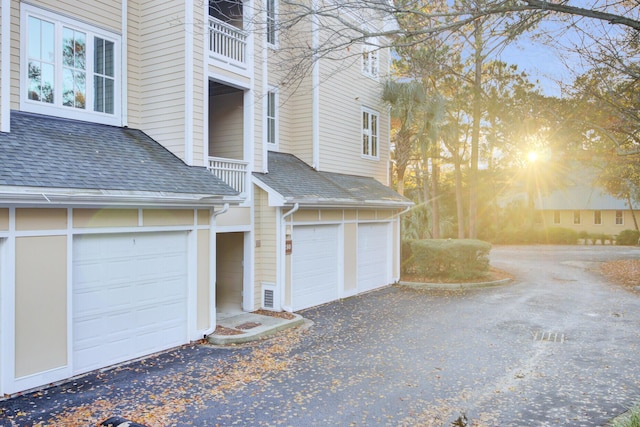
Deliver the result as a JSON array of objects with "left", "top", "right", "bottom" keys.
[{"left": 0, "top": 111, "right": 238, "bottom": 196}]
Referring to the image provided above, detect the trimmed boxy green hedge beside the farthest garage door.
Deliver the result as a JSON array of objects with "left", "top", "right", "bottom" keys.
[{"left": 402, "top": 239, "right": 491, "bottom": 280}]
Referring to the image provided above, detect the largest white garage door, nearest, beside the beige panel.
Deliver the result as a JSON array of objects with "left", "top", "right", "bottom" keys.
[{"left": 73, "top": 232, "right": 187, "bottom": 374}]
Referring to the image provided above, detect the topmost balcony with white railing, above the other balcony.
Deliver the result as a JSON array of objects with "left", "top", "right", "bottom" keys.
[{"left": 208, "top": 0, "right": 249, "bottom": 73}]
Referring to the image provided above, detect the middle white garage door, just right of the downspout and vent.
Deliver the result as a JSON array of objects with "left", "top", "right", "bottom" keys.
[{"left": 292, "top": 225, "right": 339, "bottom": 311}]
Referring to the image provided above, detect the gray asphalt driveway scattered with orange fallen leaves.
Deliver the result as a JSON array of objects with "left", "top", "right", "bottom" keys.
[{"left": 0, "top": 246, "right": 640, "bottom": 426}]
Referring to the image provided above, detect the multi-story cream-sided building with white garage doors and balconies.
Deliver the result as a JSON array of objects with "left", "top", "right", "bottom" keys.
[{"left": 0, "top": 0, "right": 410, "bottom": 394}]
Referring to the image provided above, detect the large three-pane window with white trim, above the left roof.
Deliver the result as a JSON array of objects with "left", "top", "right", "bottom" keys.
[{"left": 20, "top": 3, "right": 121, "bottom": 124}]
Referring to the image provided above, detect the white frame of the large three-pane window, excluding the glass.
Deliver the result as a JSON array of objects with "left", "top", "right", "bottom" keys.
[{"left": 20, "top": 3, "right": 122, "bottom": 126}]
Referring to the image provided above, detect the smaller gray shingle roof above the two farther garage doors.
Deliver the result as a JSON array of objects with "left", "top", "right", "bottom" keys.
[{"left": 253, "top": 152, "right": 413, "bottom": 206}]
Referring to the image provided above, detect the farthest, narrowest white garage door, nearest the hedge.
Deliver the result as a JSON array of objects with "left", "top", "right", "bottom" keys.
[{"left": 358, "top": 224, "right": 391, "bottom": 292}]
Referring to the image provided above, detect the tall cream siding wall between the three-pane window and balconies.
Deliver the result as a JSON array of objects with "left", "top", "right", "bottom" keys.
[{"left": 138, "top": 0, "right": 185, "bottom": 160}]
